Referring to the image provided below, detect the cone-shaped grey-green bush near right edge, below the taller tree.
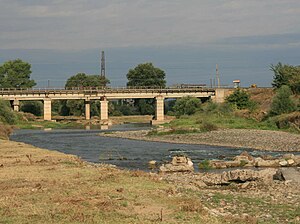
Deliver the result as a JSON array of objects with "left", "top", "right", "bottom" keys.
[{"left": 270, "top": 85, "right": 296, "bottom": 116}]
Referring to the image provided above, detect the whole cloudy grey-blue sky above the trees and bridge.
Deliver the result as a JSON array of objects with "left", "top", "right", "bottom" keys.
[{"left": 0, "top": 0, "right": 300, "bottom": 87}]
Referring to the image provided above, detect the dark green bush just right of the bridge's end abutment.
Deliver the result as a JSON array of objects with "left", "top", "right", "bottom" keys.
[{"left": 225, "top": 89, "right": 255, "bottom": 110}]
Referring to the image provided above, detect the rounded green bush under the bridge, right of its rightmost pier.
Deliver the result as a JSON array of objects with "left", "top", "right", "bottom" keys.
[{"left": 174, "top": 96, "right": 201, "bottom": 117}]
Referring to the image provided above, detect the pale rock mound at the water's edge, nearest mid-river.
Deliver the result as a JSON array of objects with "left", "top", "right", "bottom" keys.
[{"left": 159, "top": 156, "right": 194, "bottom": 172}]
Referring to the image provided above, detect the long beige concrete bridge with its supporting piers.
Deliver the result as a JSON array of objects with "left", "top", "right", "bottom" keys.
[{"left": 0, "top": 88, "right": 232, "bottom": 124}]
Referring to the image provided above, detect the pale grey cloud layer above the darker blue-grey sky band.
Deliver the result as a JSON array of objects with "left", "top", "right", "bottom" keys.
[{"left": 0, "top": 0, "right": 300, "bottom": 49}]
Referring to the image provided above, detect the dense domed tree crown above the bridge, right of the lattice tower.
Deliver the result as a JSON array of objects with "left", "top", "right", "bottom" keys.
[{"left": 127, "top": 63, "right": 166, "bottom": 87}]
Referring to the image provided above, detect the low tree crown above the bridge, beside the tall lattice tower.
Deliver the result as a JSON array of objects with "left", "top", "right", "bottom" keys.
[{"left": 65, "top": 73, "right": 109, "bottom": 88}]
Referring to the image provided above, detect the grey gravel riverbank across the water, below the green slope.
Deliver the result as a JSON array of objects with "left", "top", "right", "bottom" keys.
[{"left": 101, "top": 129, "right": 300, "bottom": 152}]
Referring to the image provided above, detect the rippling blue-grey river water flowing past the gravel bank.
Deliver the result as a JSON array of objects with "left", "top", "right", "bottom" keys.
[{"left": 10, "top": 124, "right": 290, "bottom": 170}]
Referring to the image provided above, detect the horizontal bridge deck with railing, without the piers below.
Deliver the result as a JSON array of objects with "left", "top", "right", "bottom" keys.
[{"left": 0, "top": 88, "right": 215, "bottom": 100}]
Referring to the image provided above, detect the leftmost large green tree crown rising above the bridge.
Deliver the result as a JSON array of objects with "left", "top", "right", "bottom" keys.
[{"left": 0, "top": 59, "right": 36, "bottom": 88}]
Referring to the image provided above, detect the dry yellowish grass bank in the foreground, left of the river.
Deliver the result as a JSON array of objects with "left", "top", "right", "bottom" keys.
[{"left": 0, "top": 141, "right": 221, "bottom": 223}]
